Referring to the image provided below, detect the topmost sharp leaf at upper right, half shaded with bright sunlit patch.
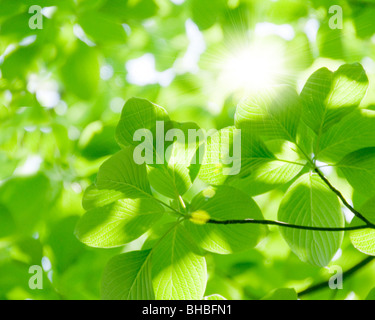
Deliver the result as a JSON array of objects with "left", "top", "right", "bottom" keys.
[{"left": 301, "top": 63, "right": 368, "bottom": 135}]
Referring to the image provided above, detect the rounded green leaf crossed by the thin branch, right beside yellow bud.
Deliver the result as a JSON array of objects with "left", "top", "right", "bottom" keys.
[{"left": 186, "top": 186, "right": 265, "bottom": 254}]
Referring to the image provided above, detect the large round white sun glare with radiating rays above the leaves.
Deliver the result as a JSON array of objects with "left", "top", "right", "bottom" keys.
[{"left": 221, "top": 45, "right": 283, "bottom": 91}]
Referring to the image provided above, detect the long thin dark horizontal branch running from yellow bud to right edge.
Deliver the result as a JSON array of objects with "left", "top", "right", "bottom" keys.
[{"left": 206, "top": 219, "right": 375, "bottom": 231}]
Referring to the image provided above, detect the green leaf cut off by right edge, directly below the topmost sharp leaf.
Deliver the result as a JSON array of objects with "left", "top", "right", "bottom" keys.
[{"left": 315, "top": 109, "right": 375, "bottom": 163}]
